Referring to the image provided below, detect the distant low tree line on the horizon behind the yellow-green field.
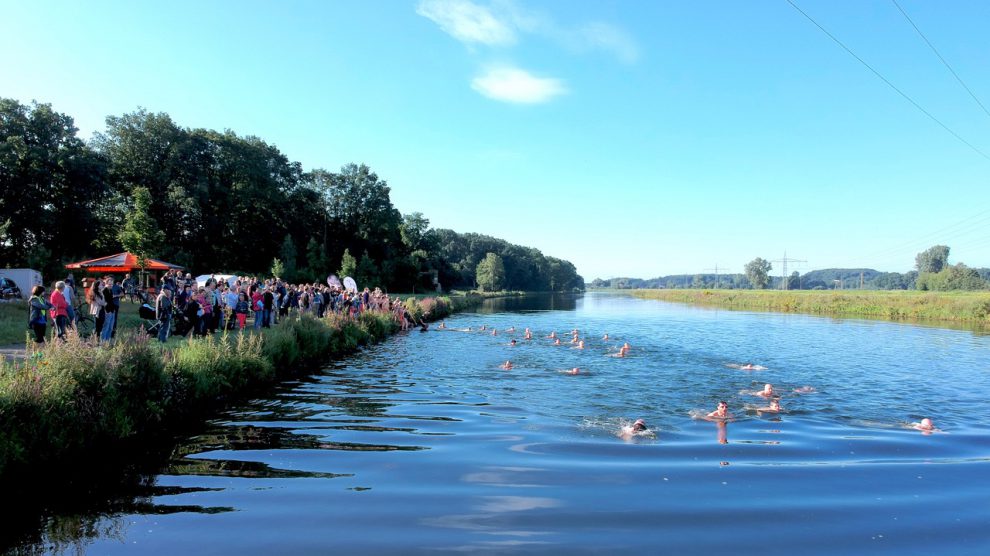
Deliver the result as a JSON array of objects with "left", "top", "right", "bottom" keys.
[{"left": 590, "top": 245, "right": 990, "bottom": 291}]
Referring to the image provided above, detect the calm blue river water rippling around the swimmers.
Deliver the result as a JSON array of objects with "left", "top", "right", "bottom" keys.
[{"left": 19, "top": 294, "right": 990, "bottom": 555}]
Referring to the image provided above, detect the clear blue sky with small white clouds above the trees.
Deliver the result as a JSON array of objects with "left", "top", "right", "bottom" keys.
[{"left": 0, "top": 0, "right": 990, "bottom": 280}]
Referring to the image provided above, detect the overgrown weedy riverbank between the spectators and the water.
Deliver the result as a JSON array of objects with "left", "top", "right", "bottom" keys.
[{"left": 0, "top": 296, "right": 480, "bottom": 484}]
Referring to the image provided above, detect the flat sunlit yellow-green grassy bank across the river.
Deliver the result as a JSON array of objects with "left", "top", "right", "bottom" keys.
[{"left": 630, "top": 290, "right": 990, "bottom": 326}]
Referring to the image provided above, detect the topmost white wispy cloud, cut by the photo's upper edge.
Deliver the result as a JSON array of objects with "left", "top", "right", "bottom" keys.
[{"left": 416, "top": 0, "right": 516, "bottom": 46}]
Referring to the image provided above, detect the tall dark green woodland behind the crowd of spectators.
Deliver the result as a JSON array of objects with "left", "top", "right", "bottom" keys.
[{"left": 0, "top": 99, "right": 584, "bottom": 291}]
